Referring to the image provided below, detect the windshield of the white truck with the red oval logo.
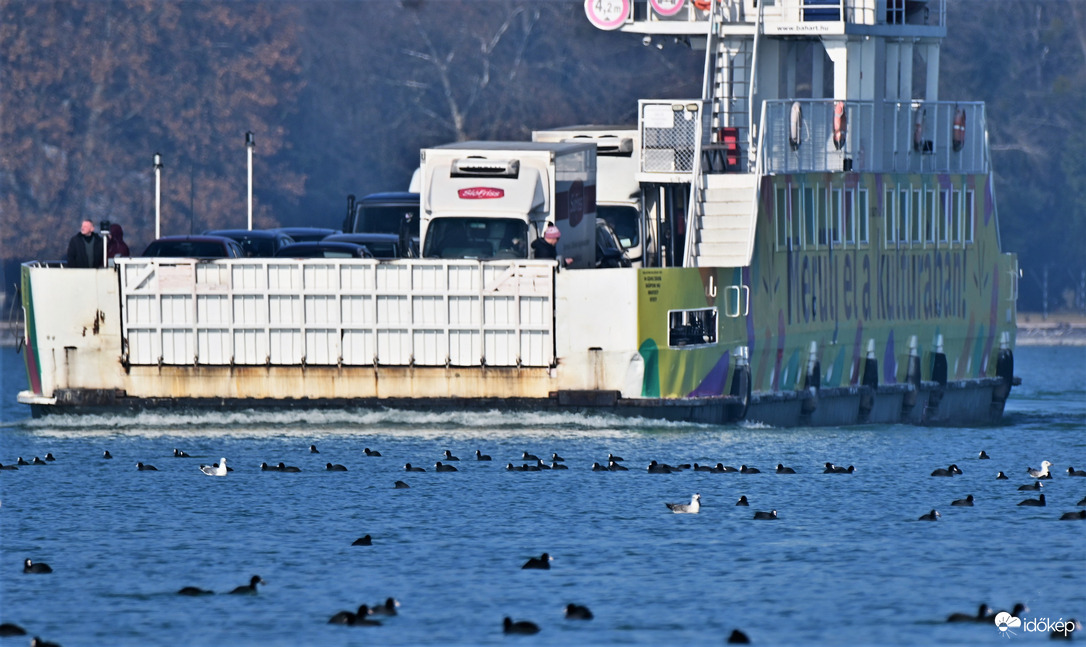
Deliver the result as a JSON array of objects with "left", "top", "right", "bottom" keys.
[{"left": 422, "top": 218, "right": 528, "bottom": 259}]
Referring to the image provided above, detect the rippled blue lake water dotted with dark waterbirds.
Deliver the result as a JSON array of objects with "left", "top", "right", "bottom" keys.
[{"left": 0, "top": 347, "right": 1086, "bottom": 647}]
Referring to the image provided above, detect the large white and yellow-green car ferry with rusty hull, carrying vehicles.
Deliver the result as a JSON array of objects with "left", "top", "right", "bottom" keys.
[{"left": 18, "top": 0, "right": 1019, "bottom": 426}]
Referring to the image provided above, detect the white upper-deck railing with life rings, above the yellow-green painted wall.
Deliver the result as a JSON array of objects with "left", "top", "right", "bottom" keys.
[{"left": 758, "top": 99, "right": 988, "bottom": 174}]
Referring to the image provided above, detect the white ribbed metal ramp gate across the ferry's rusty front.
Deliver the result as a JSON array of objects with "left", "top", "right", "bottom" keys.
[{"left": 117, "top": 258, "right": 555, "bottom": 367}]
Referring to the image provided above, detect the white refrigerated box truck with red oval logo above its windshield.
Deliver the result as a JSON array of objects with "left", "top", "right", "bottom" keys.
[{"left": 419, "top": 141, "right": 596, "bottom": 268}]
